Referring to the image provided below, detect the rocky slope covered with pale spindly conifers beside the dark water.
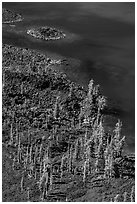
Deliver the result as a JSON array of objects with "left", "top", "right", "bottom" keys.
[{"left": 2, "top": 7, "right": 135, "bottom": 202}]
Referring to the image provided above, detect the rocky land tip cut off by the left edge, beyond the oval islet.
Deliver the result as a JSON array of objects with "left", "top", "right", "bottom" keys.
[{"left": 2, "top": 8, "right": 23, "bottom": 23}]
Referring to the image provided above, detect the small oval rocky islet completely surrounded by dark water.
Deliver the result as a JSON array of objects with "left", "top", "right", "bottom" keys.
[{"left": 27, "top": 26, "right": 66, "bottom": 41}]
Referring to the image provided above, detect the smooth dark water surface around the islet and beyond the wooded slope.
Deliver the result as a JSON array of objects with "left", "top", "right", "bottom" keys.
[{"left": 2, "top": 2, "right": 135, "bottom": 151}]
